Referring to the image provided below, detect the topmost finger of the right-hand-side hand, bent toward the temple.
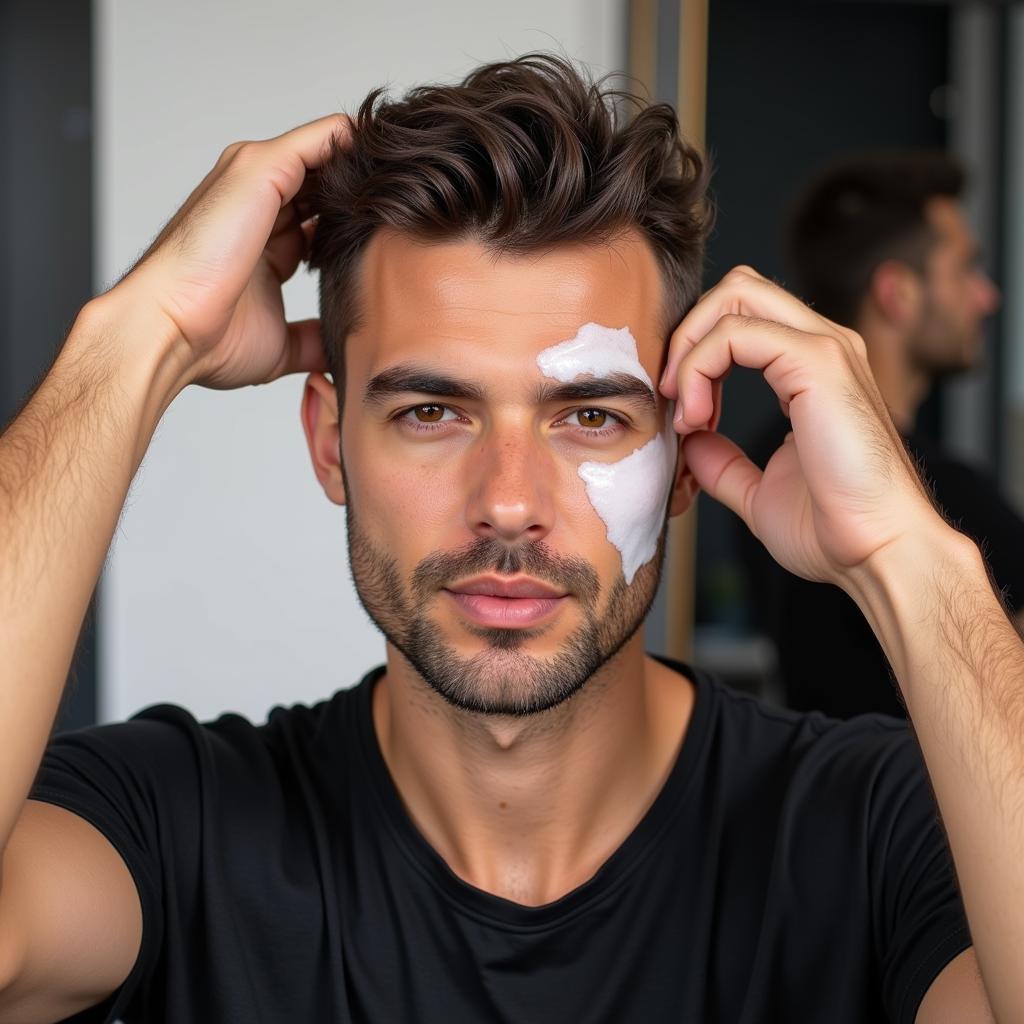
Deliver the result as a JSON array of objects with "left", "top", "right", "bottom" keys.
[{"left": 659, "top": 266, "right": 859, "bottom": 398}]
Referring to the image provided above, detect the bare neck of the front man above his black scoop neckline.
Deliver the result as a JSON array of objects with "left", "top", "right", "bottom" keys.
[{"left": 374, "top": 632, "right": 693, "bottom": 906}]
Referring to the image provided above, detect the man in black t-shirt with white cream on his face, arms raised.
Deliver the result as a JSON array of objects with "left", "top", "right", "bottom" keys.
[{"left": 0, "top": 56, "right": 1011, "bottom": 1024}]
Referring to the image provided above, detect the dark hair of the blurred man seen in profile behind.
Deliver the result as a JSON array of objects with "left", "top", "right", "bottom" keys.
[{"left": 786, "top": 150, "right": 965, "bottom": 327}]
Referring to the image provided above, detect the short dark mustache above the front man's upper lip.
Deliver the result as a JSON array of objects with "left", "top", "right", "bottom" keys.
[{"left": 412, "top": 537, "right": 600, "bottom": 606}]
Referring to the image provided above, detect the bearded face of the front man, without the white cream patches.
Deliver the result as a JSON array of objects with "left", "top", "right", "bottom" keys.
[{"left": 331, "top": 232, "right": 677, "bottom": 714}]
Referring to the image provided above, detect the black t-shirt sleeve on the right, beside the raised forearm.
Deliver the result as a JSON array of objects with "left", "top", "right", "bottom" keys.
[{"left": 868, "top": 726, "right": 972, "bottom": 1024}]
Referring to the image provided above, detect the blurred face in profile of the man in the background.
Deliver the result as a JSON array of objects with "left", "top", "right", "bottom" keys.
[{"left": 909, "top": 198, "right": 999, "bottom": 376}]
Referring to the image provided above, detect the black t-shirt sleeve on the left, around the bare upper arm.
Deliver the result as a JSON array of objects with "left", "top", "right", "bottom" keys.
[{"left": 29, "top": 706, "right": 199, "bottom": 1024}]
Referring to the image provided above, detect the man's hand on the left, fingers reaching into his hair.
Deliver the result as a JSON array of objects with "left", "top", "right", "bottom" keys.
[{"left": 110, "top": 115, "right": 349, "bottom": 388}]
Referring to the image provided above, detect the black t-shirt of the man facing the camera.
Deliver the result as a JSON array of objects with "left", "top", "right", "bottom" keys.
[{"left": 25, "top": 665, "right": 971, "bottom": 1024}]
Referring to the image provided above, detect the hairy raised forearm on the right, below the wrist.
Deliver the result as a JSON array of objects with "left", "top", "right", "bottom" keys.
[{"left": 857, "top": 526, "right": 1024, "bottom": 1020}]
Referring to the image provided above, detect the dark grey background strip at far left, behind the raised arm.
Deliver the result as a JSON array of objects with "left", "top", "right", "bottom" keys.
[{"left": 0, "top": 0, "right": 96, "bottom": 729}]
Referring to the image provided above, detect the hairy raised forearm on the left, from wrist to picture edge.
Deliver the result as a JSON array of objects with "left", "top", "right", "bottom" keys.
[{"left": 0, "top": 296, "right": 185, "bottom": 850}]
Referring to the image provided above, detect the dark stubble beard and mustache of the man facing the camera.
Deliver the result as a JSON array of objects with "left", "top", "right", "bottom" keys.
[{"left": 347, "top": 492, "right": 666, "bottom": 717}]
